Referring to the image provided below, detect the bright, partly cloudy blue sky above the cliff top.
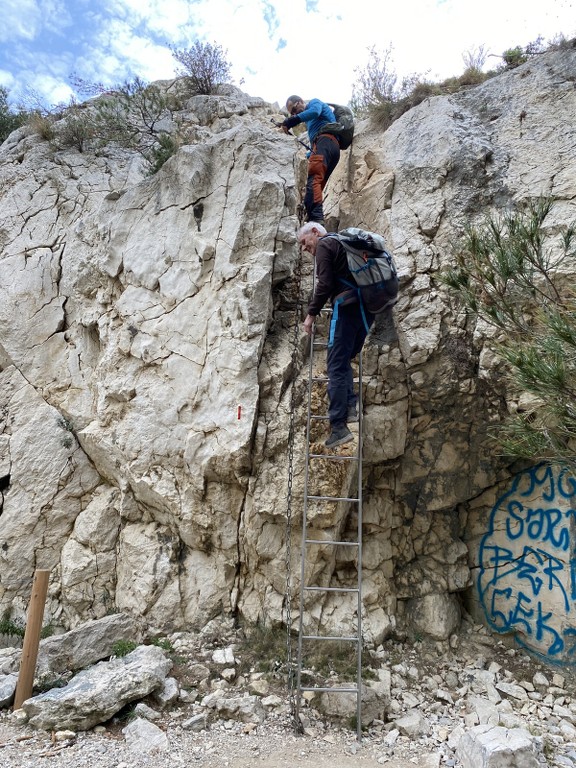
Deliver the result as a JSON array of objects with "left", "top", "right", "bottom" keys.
[{"left": 0, "top": 0, "right": 576, "bottom": 107}]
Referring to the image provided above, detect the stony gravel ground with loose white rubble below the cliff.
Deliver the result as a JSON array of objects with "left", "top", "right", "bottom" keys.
[{"left": 0, "top": 621, "right": 576, "bottom": 768}]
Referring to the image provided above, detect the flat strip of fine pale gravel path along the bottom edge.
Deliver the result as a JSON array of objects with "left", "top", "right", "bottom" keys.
[{"left": 0, "top": 715, "right": 432, "bottom": 768}]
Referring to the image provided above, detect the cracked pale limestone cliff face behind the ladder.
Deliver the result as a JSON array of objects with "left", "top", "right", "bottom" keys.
[{"left": 0, "top": 49, "right": 576, "bottom": 663}]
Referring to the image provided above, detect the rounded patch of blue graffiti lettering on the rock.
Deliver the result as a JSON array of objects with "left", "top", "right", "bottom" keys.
[{"left": 477, "top": 465, "right": 576, "bottom": 664}]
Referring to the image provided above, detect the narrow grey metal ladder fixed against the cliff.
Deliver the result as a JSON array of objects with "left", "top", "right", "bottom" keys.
[{"left": 295, "top": 310, "right": 362, "bottom": 741}]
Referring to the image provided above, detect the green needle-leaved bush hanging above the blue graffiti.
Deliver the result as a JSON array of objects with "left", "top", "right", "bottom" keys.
[{"left": 440, "top": 198, "right": 576, "bottom": 465}]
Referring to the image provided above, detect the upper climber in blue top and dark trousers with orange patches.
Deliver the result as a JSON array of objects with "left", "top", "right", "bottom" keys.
[{"left": 282, "top": 96, "right": 340, "bottom": 224}]
